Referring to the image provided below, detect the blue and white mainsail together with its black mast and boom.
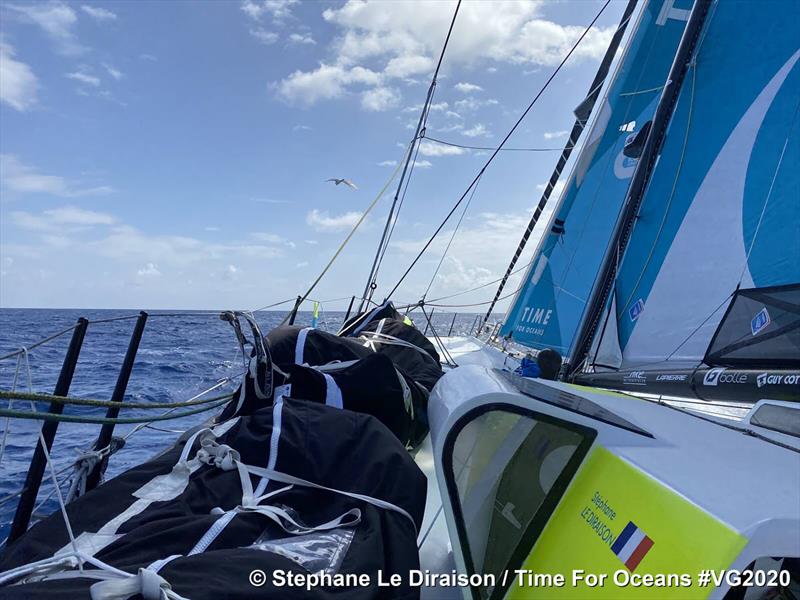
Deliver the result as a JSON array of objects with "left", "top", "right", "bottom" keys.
[{"left": 571, "top": 0, "right": 800, "bottom": 400}]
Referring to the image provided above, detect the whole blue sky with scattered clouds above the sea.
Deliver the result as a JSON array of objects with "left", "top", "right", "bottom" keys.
[{"left": 0, "top": 0, "right": 624, "bottom": 310}]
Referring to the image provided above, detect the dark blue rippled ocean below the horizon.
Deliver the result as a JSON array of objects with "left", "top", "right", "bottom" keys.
[{"left": 0, "top": 309, "right": 476, "bottom": 540}]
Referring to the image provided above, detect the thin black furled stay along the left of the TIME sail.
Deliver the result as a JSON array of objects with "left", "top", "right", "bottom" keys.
[{"left": 483, "top": 0, "right": 637, "bottom": 323}]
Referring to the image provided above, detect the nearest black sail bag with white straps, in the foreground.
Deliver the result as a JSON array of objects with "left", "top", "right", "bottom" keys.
[{"left": 0, "top": 398, "right": 426, "bottom": 600}]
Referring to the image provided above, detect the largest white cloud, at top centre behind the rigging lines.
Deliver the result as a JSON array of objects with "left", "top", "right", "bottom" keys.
[{"left": 276, "top": 0, "right": 613, "bottom": 110}]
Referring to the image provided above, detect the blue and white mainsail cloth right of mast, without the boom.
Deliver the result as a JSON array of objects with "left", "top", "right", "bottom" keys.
[{"left": 613, "top": 0, "right": 800, "bottom": 368}]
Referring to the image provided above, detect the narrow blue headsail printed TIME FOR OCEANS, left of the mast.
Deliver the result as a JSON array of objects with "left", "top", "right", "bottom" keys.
[{"left": 501, "top": 0, "right": 691, "bottom": 354}]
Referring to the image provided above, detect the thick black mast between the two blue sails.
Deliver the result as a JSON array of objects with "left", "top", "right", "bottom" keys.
[{"left": 562, "top": 0, "right": 711, "bottom": 379}]
